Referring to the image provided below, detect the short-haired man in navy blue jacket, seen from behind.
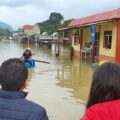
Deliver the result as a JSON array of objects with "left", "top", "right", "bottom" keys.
[{"left": 0, "top": 59, "right": 48, "bottom": 120}]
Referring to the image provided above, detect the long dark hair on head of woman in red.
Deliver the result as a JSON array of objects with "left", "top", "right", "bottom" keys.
[{"left": 86, "top": 62, "right": 120, "bottom": 108}]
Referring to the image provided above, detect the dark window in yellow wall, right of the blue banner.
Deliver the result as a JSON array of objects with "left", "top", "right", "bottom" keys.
[{"left": 104, "top": 31, "right": 112, "bottom": 49}]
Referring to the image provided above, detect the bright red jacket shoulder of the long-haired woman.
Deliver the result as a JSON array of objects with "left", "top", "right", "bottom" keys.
[{"left": 81, "top": 100, "right": 120, "bottom": 120}]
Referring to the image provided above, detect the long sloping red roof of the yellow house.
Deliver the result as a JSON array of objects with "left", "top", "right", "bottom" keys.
[{"left": 68, "top": 8, "right": 120, "bottom": 27}]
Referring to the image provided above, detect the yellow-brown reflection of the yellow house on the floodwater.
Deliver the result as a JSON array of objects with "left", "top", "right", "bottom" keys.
[{"left": 57, "top": 60, "right": 92, "bottom": 103}]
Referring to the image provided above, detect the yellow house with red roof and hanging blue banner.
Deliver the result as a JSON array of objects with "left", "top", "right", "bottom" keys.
[{"left": 59, "top": 8, "right": 120, "bottom": 63}]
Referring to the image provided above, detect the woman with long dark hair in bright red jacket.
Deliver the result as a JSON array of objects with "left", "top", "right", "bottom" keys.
[{"left": 80, "top": 62, "right": 120, "bottom": 120}]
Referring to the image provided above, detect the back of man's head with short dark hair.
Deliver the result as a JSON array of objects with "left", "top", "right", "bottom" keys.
[{"left": 0, "top": 58, "right": 28, "bottom": 91}]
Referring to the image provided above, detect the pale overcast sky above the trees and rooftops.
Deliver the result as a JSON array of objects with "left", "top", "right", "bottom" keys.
[{"left": 0, "top": 0, "right": 120, "bottom": 29}]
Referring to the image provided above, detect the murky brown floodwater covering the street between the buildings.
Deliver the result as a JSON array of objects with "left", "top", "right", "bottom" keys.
[{"left": 0, "top": 41, "right": 93, "bottom": 120}]
